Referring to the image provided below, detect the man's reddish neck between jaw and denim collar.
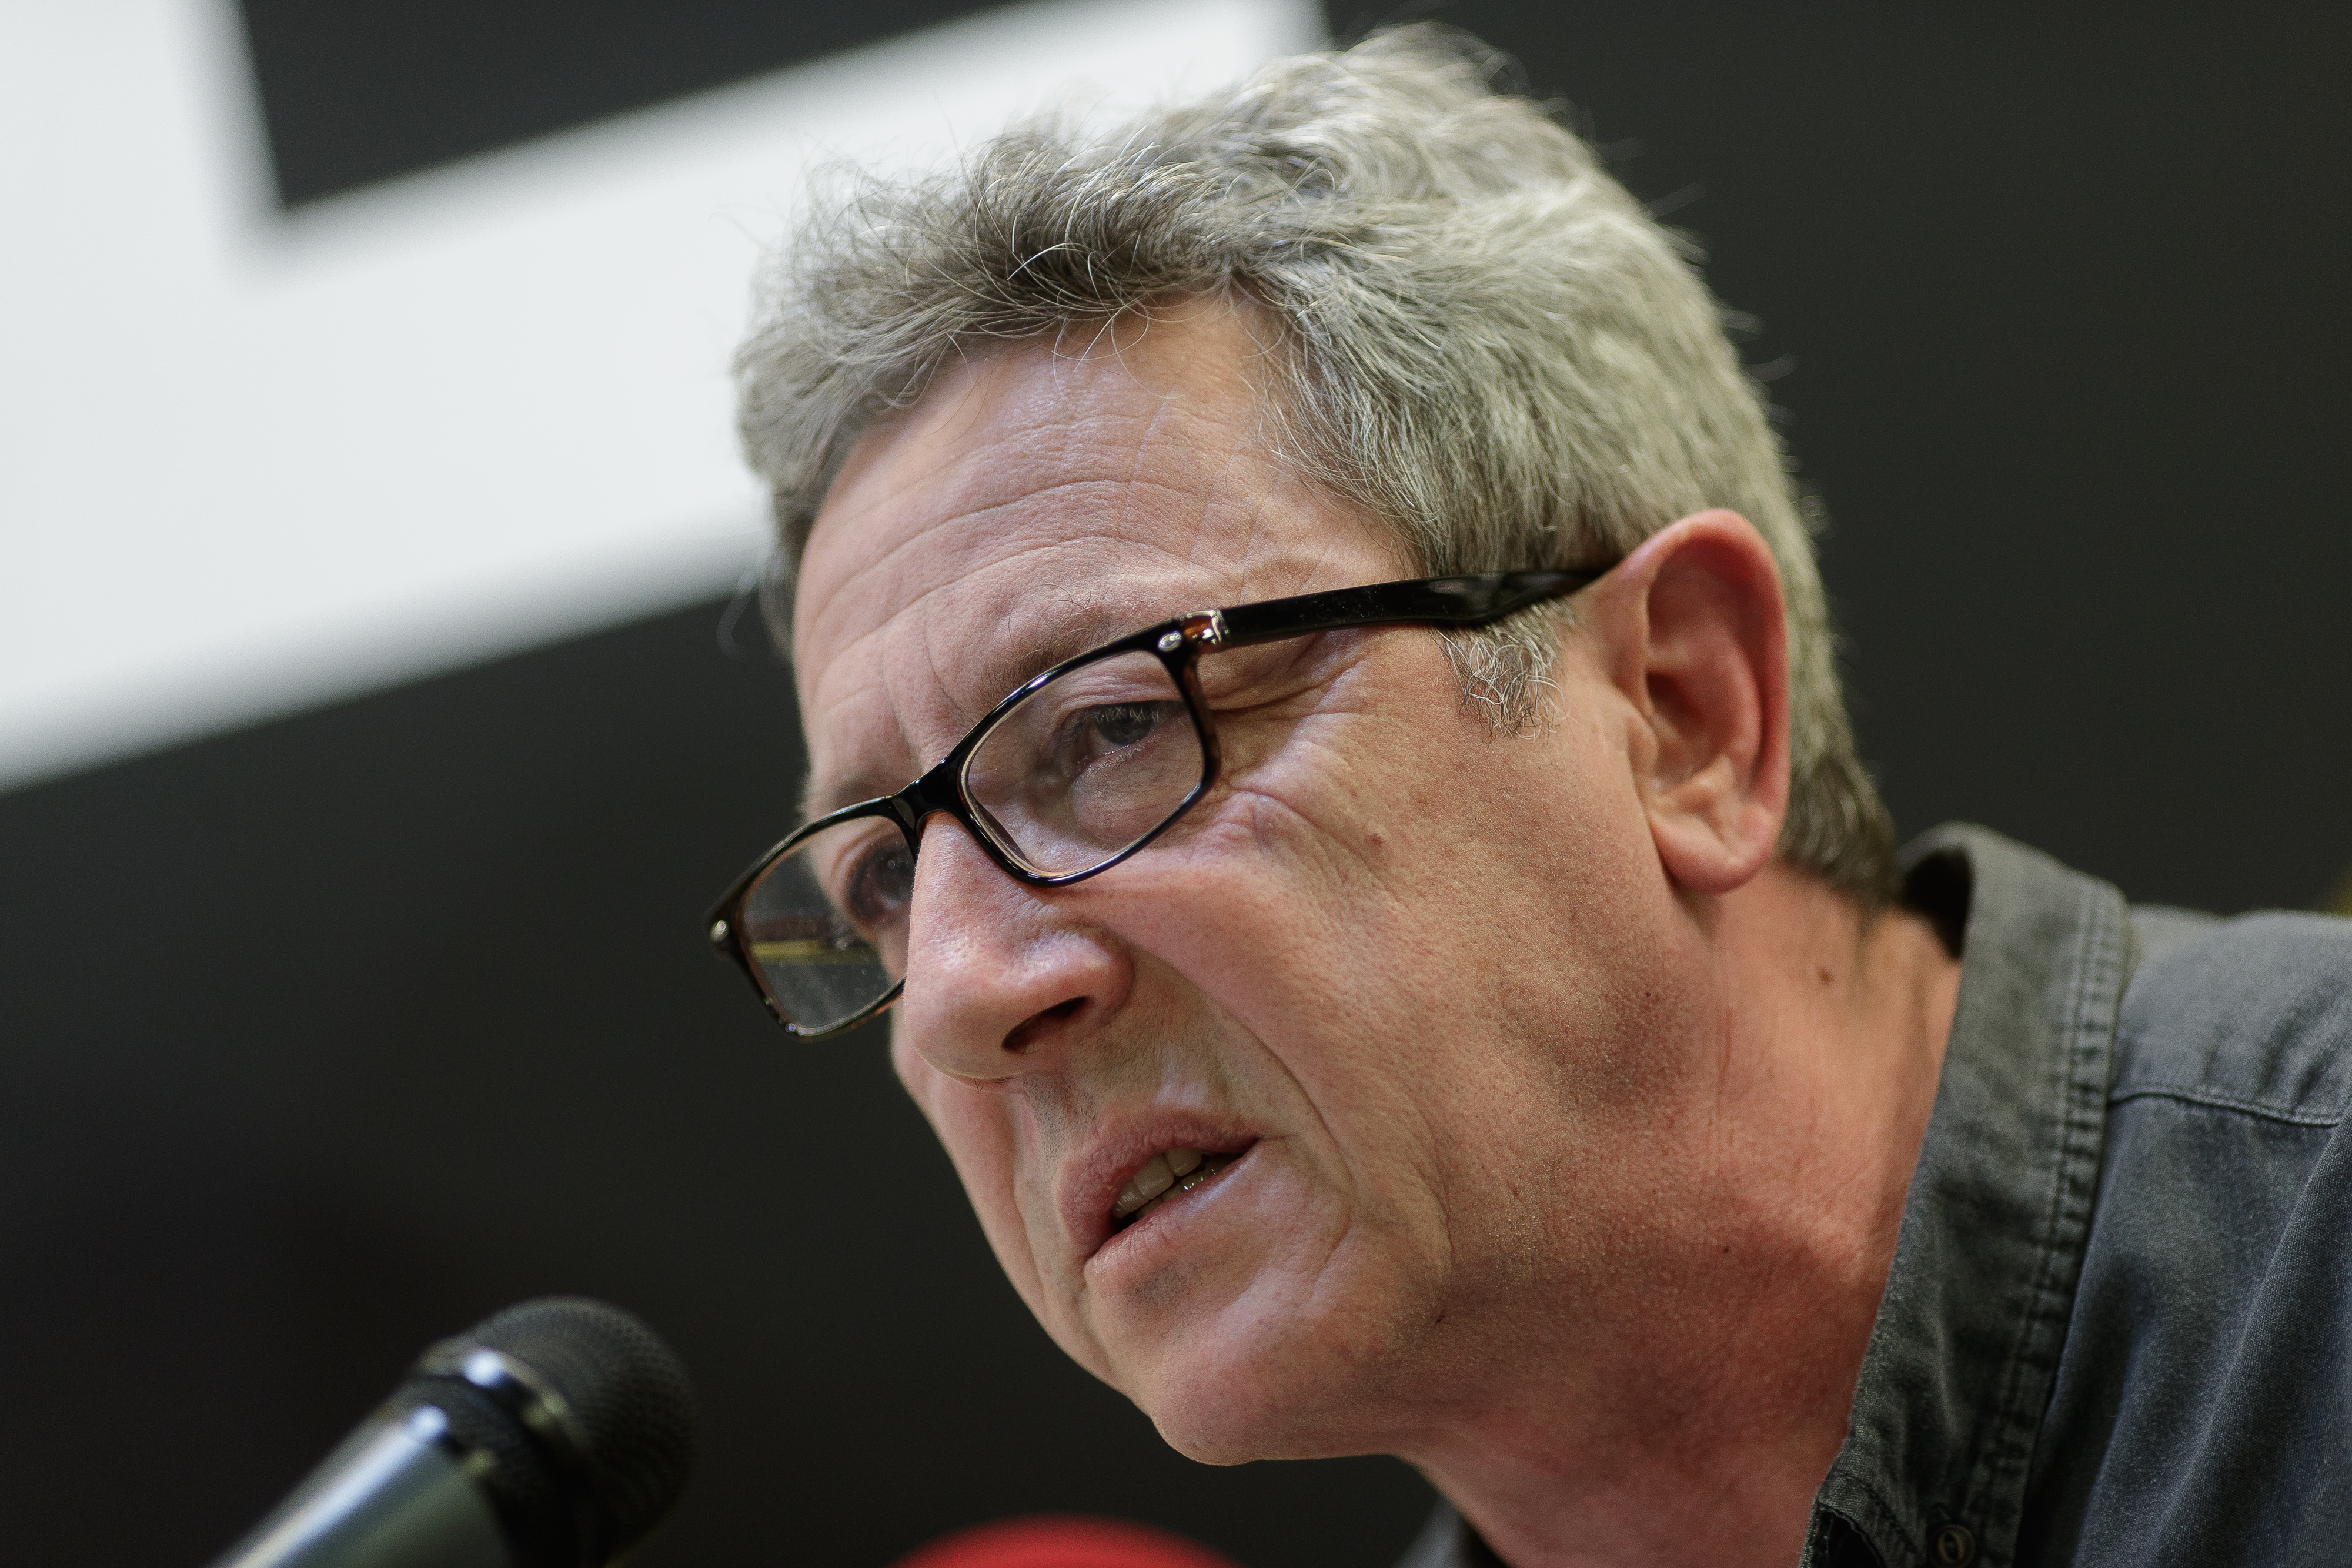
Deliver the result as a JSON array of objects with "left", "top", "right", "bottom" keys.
[{"left": 1406, "top": 865, "right": 1959, "bottom": 1568}]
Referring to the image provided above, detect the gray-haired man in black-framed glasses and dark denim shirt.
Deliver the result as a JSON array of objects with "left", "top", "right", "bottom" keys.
[{"left": 713, "top": 31, "right": 2352, "bottom": 1568}]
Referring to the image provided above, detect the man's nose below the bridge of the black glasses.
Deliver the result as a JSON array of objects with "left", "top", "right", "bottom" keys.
[{"left": 894, "top": 815, "right": 1134, "bottom": 1086}]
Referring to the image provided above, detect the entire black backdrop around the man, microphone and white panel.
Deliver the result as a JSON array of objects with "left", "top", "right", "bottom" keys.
[{"left": 0, "top": 0, "right": 2352, "bottom": 1568}]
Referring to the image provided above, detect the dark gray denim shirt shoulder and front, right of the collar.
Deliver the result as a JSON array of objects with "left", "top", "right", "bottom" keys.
[{"left": 2016, "top": 910, "right": 2352, "bottom": 1568}]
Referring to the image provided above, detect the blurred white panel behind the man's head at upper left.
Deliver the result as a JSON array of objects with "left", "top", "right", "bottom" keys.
[{"left": 0, "top": 0, "right": 1322, "bottom": 785}]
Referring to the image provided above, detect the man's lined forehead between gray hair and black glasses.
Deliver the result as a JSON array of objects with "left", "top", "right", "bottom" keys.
[{"left": 793, "top": 308, "right": 1399, "bottom": 806}]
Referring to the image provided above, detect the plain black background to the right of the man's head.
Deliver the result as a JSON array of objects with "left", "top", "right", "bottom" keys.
[{"left": 1442, "top": 0, "right": 2352, "bottom": 910}]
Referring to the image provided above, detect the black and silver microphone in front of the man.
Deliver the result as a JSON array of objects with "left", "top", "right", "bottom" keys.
[{"left": 214, "top": 1295, "right": 694, "bottom": 1568}]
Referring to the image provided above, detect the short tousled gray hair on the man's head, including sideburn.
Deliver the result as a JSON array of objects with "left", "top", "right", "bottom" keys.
[{"left": 736, "top": 26, "right": 1893, "bottom": 905}]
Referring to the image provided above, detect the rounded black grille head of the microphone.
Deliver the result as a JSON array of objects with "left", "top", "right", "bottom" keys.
[{"left": 402, "top": 1295, "right": 694, "bottom": 1566}]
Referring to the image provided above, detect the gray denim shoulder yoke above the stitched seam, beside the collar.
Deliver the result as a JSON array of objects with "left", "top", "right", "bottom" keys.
[{"left": 2112, "top": 910, "right": 2352, "bottom": 1126}]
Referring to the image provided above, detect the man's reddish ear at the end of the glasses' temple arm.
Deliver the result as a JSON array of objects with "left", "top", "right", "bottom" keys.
[{"left": 1585, "top": 510, "right": 1788, "bottom": 893}]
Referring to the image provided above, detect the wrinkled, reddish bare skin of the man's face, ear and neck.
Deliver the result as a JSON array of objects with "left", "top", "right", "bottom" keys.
[{"left": 795, "top": 306, "right": 1957, "bottom": 1563}]
